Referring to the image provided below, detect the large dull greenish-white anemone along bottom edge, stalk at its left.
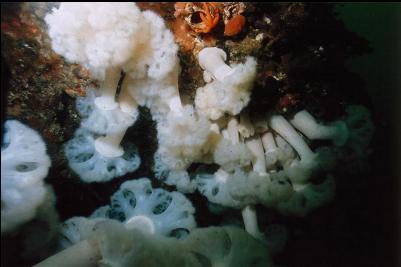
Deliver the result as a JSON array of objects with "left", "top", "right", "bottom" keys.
[{"left": 36, "top": 220, "right": 272, "bottom": 267}]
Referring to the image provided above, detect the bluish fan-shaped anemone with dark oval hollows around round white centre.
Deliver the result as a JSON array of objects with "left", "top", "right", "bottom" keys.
[{"left": 91, "top": 178, "right": 196, "bottom": 235}]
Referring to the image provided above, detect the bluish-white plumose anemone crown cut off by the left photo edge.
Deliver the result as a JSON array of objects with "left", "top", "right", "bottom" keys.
[{"left": 1, "top": 120, "right": 51, "bottom": 233}]
